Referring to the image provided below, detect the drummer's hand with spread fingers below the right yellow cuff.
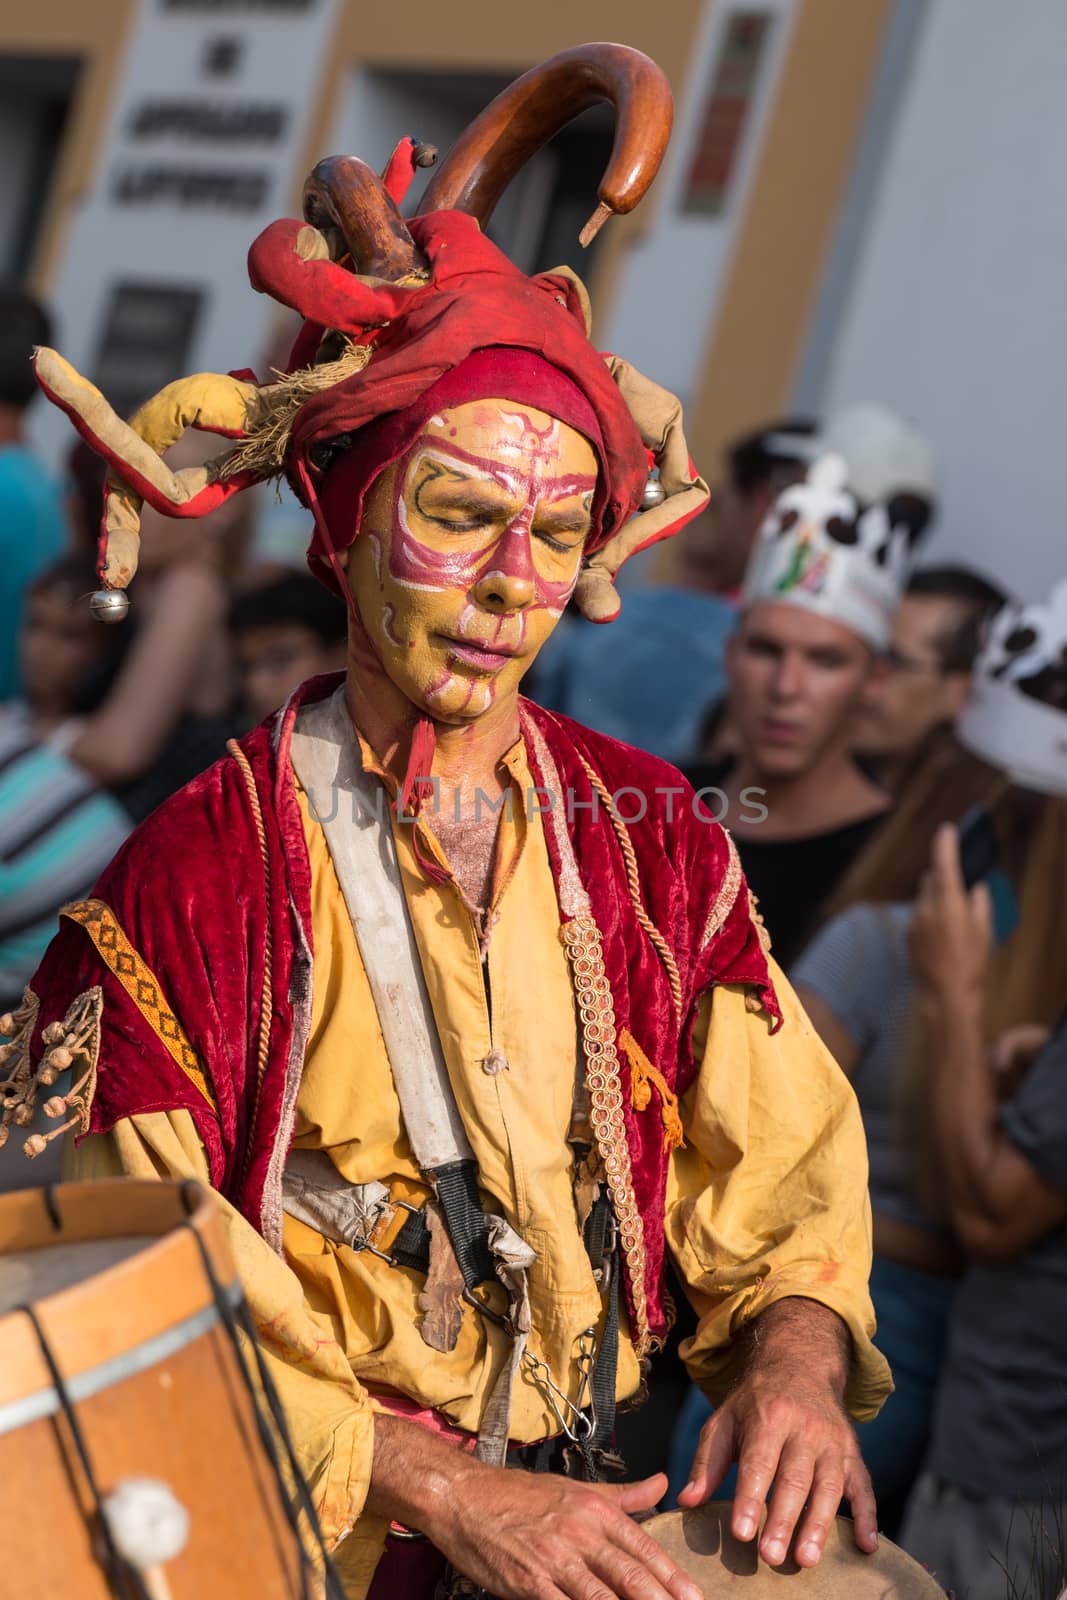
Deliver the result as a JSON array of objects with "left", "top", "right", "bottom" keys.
[{"left": 678, "top": 1299, "right": 878, "bottom": 1566}]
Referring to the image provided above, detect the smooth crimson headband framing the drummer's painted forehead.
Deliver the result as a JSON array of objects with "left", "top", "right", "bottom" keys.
[{"left": 307, "top": 347, "right": 606, "bottom": 590}]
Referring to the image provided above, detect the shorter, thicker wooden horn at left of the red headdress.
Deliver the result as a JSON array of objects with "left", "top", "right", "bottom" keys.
[{"left": 304, "top": 155, "right": 426, "bottom": 283}]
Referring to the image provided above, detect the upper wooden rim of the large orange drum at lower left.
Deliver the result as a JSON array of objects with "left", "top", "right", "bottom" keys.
[{"left": 0, "top": 1178, "right": 240, "bottom": 1435}]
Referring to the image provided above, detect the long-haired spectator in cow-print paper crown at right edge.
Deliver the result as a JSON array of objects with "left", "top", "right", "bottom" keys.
[{"left": 793, "top": 582, "right": 1067, "bottom": 1534}]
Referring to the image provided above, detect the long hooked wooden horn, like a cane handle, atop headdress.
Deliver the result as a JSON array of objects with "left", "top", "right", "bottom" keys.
[{"left": 419, "top": 45, "right": 673, "bottom": 245}]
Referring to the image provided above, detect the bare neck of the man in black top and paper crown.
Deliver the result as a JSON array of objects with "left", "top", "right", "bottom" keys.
[{"left": 725, "top": 746, "right": 888, "bottom": 840}]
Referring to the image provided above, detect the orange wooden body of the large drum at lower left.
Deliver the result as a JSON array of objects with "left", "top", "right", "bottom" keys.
[{"left": 0, "top": 1179, "right": 299, "bottom": 1600}]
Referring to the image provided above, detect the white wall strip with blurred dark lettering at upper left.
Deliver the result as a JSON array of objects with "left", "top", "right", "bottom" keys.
[{"left": 32, "top": 0, "right": 341, "bottom": 462}]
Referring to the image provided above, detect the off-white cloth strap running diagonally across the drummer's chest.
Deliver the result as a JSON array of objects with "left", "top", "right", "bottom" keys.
[{"left": 291, "top": 685, "right": 474, "bottom": 1173}]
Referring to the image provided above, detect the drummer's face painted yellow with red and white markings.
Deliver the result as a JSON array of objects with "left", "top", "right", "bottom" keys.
[{"left": 347, "top": 400, "right": 597, "bottom": 723}]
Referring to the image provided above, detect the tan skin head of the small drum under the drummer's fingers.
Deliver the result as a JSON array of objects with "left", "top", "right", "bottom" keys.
[{"left": 641, "top": 1501, "right": 944, "bottom": 1600}]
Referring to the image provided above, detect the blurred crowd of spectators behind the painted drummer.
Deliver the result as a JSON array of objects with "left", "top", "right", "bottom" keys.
[{"left": 0, "top": 281, "right": 1067, "bottom": 1600}]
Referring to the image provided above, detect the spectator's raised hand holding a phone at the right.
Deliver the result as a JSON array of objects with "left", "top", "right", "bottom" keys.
[{"left": 909, "top": 822, "right": 993, "bottom": 1002}]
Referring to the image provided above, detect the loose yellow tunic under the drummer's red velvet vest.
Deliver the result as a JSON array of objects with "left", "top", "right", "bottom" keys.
[{"left": 72, "top": 732, "right": 889, "bottom": 1597}]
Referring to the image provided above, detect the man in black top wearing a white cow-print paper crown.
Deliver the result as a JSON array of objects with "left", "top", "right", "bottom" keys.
[{"left": 688, "top": 456, "right": 907, "bottom": 968}]
